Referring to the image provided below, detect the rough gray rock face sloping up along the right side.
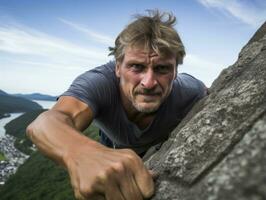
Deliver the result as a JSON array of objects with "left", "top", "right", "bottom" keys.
[{"left": 145, "top": 22, "right": 266, "bottom": 200}]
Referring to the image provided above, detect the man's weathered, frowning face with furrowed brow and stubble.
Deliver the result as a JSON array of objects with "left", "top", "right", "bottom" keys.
[{"left": 116, "top": 47, "right": 177, "bottom": 113}]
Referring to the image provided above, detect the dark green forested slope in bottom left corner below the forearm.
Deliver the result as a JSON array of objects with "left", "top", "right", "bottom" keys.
[{"left": 0, "top": 152, "right": 75, "bottom": 200}]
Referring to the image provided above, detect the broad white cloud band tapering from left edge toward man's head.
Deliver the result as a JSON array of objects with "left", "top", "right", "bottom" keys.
[{"left": 0, "top": 25, "right": 110, "bottom": 62}]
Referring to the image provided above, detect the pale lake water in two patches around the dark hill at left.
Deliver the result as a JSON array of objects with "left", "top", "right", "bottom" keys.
[{"left": 0, "top": 100, "right": 56, "bottom": 137}]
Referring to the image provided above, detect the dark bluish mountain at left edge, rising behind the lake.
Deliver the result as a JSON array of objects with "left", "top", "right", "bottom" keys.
[{"left": 0, "top": 90, "right": 42, "bottom": 118}]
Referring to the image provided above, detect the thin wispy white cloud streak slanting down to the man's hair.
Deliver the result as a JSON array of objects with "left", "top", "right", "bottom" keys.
[{"left": 59, "top": 18, "right": 114, "bottom": 46}]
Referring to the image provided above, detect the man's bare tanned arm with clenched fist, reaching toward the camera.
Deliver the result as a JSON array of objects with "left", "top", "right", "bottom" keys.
[{"left": 27, "top": 97, "right": 154, "bottom": 200}]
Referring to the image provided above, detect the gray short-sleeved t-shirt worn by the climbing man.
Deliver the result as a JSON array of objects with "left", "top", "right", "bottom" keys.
[{"left": 62, "top": 62, "right": 205, "bottom": 153}]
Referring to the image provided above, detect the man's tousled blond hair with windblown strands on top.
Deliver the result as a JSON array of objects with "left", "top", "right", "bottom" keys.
[{"left": 109, "top": 10, "right": 185, "bottom": 64}]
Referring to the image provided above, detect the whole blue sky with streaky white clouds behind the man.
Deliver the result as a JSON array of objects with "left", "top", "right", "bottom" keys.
[{"left": 0, "top": 0, "right": 266, "bottom": 95}]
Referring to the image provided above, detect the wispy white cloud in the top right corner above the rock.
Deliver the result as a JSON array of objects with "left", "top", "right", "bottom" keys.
[{"left": 198, "top": 0, "right": 266, "bottom": 27}]
